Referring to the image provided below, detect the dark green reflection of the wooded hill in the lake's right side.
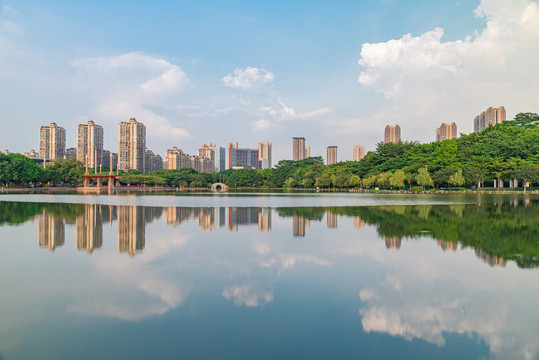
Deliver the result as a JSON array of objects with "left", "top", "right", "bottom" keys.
[{"left": 331, "top": 198, "right": 539, "bottom": 268}]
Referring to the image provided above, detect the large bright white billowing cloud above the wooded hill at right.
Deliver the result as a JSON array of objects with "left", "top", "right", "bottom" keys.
[{"left": 358, "top": 0, "right": 539, "bottom": 140}]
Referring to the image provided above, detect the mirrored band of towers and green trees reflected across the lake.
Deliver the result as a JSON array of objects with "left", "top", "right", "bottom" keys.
[{"left": 1, "top": 198, "right": 539, "bottom": 267}]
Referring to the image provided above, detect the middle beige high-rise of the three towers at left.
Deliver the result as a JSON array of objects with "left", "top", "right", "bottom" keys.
[{"left": 77, "top": 120, "right": 103, "bottom": 168}]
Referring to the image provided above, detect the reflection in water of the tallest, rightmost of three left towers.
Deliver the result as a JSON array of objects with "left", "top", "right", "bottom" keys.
[{"left": 117, "top": 206, "right": 146, "bottom": 256}]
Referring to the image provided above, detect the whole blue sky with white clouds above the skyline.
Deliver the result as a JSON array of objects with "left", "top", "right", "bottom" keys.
[{"left": 0, "top": 0, "right": 539, "bottom": 164}]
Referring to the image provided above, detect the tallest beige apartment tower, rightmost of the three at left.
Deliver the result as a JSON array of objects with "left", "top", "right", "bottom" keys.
[{"left": 118, "top": 118, "right": 146, "bottom": 171}]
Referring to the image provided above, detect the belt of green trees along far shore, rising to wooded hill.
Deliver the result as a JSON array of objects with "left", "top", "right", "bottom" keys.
[{"left": 0, "top": 113, "right": 539, "bottom": 190}]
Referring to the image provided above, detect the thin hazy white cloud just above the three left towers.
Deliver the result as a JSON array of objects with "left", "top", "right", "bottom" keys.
[{"left": 69, "top": 52, "right": 190, "bottom": 143}]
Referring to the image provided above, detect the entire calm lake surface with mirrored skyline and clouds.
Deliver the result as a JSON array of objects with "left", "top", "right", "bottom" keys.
[{"left": 0, "top": 194, "right": 539, "bottom": 360}]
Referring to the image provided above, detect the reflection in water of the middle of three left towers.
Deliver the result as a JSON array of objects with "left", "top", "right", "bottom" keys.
[{"left": 75, "top": 204, "right": 103, "bottom": 254}]
